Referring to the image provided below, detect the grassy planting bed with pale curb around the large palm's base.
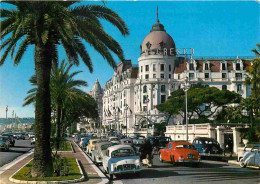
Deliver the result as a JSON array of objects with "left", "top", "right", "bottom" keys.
[{"left": 10, "top": 155, "right": 85, "bottom": 183}]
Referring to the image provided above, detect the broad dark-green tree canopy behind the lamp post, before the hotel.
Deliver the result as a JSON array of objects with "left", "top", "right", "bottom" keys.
[{"left": 156, "top": 83, "right": 241, "bottom": 123}]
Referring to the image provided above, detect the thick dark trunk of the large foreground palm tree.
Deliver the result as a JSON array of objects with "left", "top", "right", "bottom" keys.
[{"left": 31, "top": 44, "right": 53, "bottom": 177}]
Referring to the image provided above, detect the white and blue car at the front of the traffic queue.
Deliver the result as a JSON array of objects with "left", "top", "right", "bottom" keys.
[{"left": 103, "top": 145, "right": 142, "bottom": 179}]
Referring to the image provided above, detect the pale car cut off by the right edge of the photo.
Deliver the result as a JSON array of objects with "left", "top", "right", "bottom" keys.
[{"left": 239, "top": 144, "right": 260, "bottom": 168}]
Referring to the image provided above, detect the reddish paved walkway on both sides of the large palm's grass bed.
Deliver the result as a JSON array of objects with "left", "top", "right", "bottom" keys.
[{"left": 0, "top": 142, "right": 102, "bottom": 184}]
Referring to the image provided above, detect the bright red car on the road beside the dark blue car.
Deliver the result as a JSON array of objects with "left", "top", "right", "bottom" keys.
[{"left": 159, "top": 141, "right": 200, "bottom": 166}]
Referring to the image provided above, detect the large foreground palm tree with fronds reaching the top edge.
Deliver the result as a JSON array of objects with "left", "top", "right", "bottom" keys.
[{"left": 0, "top": 1, "right": 129, "bottom": 177}]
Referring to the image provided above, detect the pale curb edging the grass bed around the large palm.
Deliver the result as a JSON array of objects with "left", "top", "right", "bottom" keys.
[{"left": 9, "top": 159, "right": 85, "bottom": 184}]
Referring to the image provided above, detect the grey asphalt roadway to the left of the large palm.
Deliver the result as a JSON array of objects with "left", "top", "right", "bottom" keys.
[{"left": 0, "top": 138, "right": 33, "bottom": 167}]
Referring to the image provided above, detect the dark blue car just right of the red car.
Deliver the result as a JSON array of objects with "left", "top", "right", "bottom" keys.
[{"left": 192, "top": 137, "right": 223, "bottom": 156}]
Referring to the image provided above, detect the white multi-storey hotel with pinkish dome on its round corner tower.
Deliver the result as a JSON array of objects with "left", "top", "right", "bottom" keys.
[{"left": 92, "top": 16, "right": 252, "bottom": 139}]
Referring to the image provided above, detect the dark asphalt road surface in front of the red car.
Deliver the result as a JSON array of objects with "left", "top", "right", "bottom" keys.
[{"left": 85, "top": 150, "right": 260, "bottom": 184}]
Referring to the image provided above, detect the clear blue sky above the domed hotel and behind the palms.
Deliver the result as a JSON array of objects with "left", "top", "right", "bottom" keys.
[{"left": 0, "top": 1, "right": 260, "bottom": 117}]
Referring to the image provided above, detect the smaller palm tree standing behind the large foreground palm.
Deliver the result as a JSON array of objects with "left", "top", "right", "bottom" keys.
[{"left": 24, "top": 60, "right": 94, "bottom": 148}]
